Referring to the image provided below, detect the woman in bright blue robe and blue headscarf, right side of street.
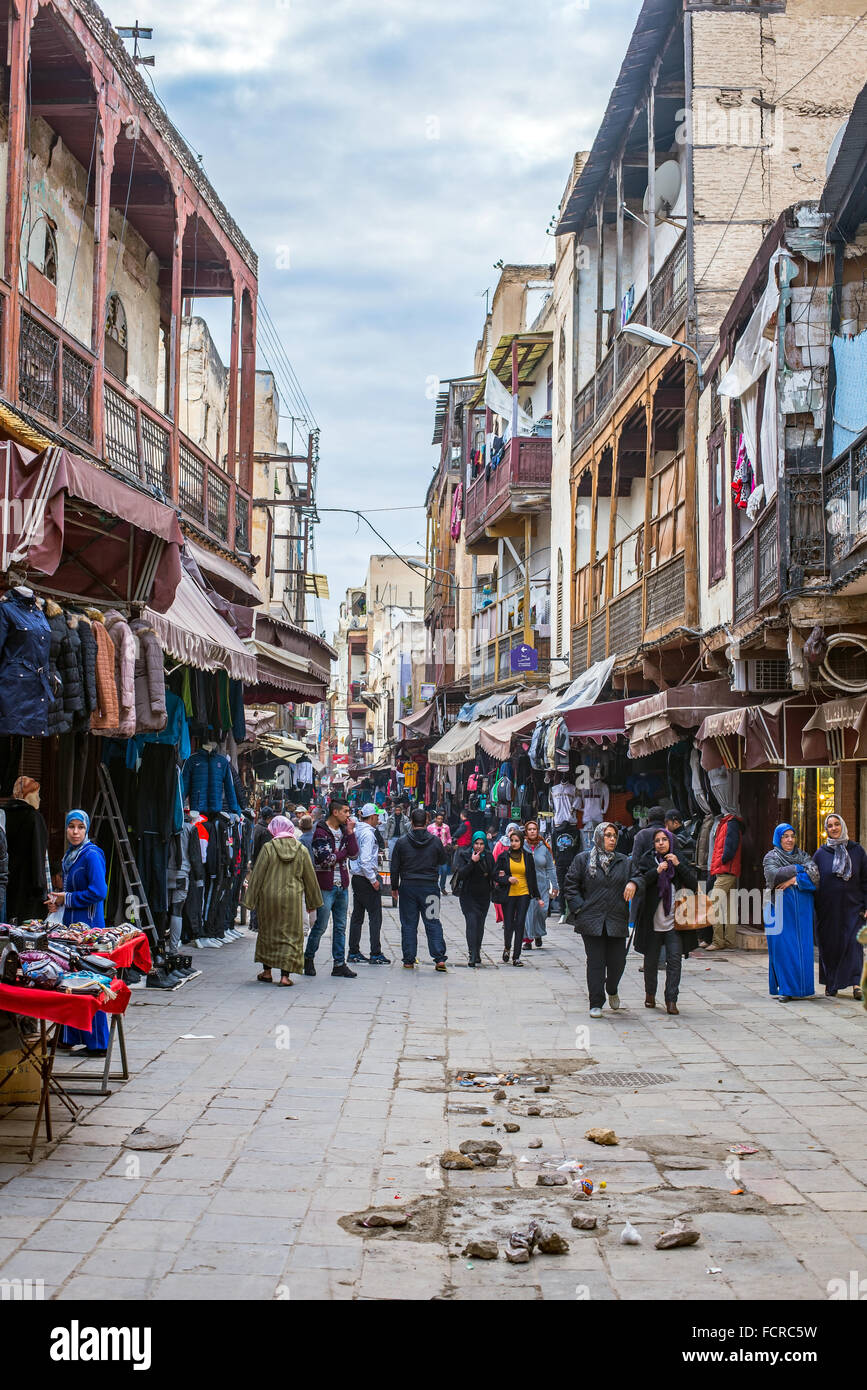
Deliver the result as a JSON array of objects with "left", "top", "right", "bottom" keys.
[{"left": 763, "top": 824, "right": 818, "bottom": 1004}]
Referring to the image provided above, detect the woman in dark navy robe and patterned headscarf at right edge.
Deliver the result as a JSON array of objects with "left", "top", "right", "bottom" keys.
[{"left": 813, "top": 815, "right": 867, "bottom": 999}]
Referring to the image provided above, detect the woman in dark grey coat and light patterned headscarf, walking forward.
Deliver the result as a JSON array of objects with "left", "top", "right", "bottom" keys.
[{"left": 563, "top": 820, "right": 636, "bottom": 1019}]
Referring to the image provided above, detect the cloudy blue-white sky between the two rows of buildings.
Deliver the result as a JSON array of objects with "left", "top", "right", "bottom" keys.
[{"left": 103, "top": 0, "right": 641, "bottom": 637}]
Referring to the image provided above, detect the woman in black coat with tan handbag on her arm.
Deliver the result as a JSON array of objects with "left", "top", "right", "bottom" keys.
[{"left": 635, "top": 828, "right": 699, "bottom": 1013}]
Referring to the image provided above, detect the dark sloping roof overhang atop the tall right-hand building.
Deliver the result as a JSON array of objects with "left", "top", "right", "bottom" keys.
[{"left": 557, "top": 0, "right": 681, "bottom": 236}]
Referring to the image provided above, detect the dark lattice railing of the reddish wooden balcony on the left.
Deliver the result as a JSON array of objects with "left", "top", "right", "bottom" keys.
[{"left": 9, "top": 297, "right": 250, "bottom": 550}]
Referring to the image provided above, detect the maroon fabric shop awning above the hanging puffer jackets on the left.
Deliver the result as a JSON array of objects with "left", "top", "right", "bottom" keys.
[{"left": 0, "top": 439, "right": 183, "bottom": 613}]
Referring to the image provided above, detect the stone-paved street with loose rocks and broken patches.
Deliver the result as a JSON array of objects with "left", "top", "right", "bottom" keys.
[{"left": 0, "top": 898, "right": 867, "bottom": 1300}]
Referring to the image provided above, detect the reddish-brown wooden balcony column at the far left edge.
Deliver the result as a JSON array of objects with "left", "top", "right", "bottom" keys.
[{"left": 3, "top": 0, "right": 32, "bottom": 400}]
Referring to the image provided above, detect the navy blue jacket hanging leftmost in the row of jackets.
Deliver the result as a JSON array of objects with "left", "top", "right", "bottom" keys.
[{"left": 0, "top": 589, "right": 54, "bottom": 738}]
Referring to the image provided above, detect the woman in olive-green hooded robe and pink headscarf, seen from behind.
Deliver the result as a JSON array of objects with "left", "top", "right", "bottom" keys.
[{"left": 245, "top": 816, "right": 322, "bottom": 986}]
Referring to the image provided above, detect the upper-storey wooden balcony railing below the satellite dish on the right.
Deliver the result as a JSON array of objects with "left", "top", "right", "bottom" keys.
[{"left": 572, "top": 238, "right": 686, "bottom": 446}]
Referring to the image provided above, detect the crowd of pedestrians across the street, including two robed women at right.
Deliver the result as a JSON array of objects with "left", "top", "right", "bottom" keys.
[{"left": 237, "top": 798, "right": 867, "bottom": 1017}]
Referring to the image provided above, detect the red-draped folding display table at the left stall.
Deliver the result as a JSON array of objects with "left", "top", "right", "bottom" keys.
[{"left": 0, "top": 973, "right": 132, "bottom": 1159}]
